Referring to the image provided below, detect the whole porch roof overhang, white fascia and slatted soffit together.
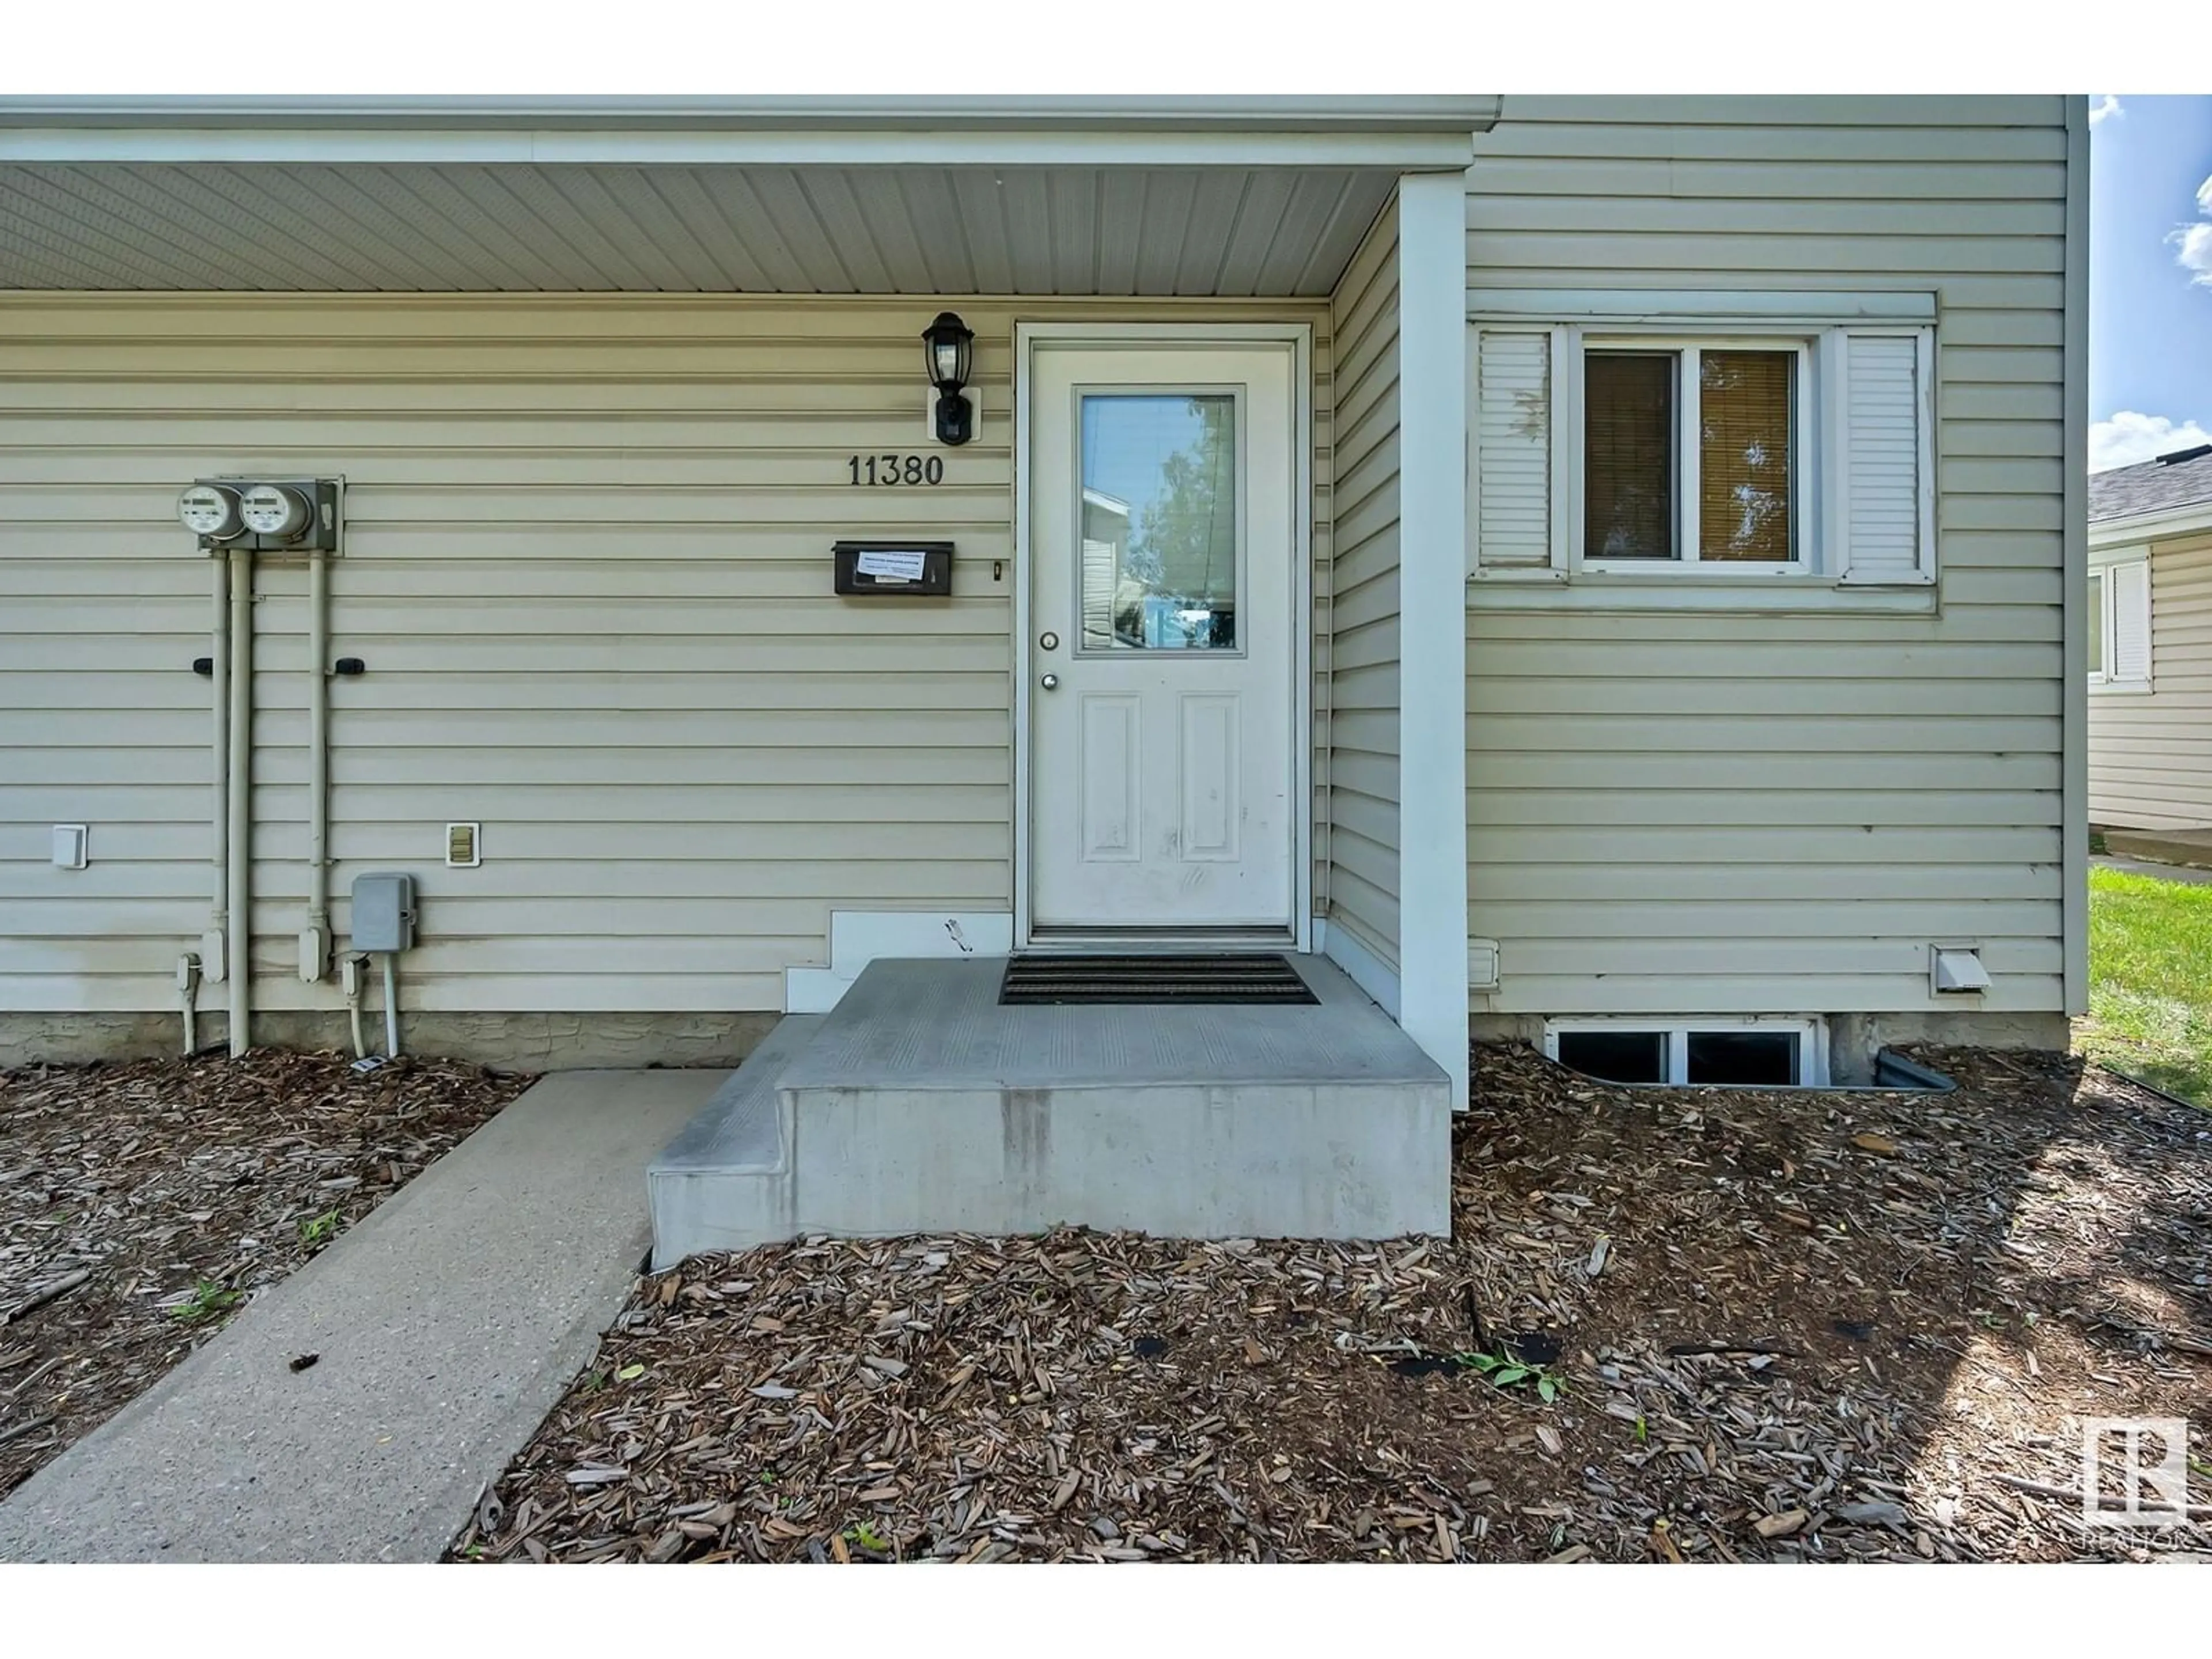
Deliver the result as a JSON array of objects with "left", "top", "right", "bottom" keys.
[{"left": 0, "top": 97, "right": 1498, "bottom": 297}]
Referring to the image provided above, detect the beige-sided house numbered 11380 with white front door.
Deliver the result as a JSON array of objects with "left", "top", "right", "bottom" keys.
[{"left": 0, "top": 95, "right": 2088, "bottom": 1106}]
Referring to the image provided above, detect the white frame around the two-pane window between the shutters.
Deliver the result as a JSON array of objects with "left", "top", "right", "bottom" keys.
[{"left": 1553, "top": 329, "right": 1825, "bottom": 582}]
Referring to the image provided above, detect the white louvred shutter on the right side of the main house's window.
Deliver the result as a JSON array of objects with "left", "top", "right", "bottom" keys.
[{"left": 1830, "top": 332, "right": 1936, "bottom": 584}]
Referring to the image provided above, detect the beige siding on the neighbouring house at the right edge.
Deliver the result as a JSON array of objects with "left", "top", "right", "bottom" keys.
[{"left": 2088, "top": 535, "right": 2212, "bottom": 830}]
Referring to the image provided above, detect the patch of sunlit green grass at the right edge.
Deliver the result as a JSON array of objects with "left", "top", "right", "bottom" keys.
[{"left": 2080, "top": 869, "right": 2212, "bottom": 1106}]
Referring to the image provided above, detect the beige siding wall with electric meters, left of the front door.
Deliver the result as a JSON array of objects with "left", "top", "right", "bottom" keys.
[{"left": 0, "top": 297, "right": 1330, "bottom": 1011}]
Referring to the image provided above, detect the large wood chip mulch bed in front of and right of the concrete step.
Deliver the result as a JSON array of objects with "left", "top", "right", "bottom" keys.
[{"left": 453, "top": 1048, "right": 2212, "bottom": 1562}]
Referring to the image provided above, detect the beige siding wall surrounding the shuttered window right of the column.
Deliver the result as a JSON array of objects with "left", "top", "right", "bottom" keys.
[{"left": 1467, "top": 97, "right": 2066, "bottom": 1013}]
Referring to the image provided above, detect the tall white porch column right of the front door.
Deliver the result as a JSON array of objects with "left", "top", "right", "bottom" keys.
[{"left": 1398, "top": 173, "right": 1467, "bottom": 1104}]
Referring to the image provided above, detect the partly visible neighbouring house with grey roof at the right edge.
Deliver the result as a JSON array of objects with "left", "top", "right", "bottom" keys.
[{"left": 2088, "top": 445, "right": 2212, "bottom": 830}]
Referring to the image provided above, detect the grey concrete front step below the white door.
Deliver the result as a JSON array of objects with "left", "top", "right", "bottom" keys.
[{"left": 653, "top": 958, "right": 1451, "bottom": 1263}]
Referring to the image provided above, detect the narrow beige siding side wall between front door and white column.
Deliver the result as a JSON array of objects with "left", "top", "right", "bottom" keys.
[{"left": 1325, "top": 201, "right": 1398, "bottom": 969}]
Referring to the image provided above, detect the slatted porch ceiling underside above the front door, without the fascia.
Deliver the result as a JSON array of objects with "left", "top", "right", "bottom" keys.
[{"left": 0, "top": 161, "right": 1396, "bottom": 297}]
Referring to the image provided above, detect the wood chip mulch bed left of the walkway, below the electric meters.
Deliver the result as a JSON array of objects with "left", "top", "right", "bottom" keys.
[{"left": 0, "top": 1048, "right": 529, "bottom": 1495}]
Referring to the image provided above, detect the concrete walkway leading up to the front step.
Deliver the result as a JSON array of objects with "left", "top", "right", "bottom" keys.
[{"left": 0, "top": 1071, "right": 728, "bottom": 1562}]
